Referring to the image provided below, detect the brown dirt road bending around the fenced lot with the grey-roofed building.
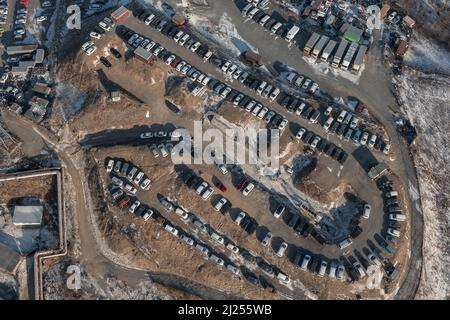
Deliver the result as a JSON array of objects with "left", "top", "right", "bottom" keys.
[{"left": 3, "top": 112, "right": 241, "bottom": 300}]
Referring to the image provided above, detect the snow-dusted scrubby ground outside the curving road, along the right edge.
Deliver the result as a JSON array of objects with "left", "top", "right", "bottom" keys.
[{"left": 397, "top": 68, "right": 450, "bottom": 299}]
